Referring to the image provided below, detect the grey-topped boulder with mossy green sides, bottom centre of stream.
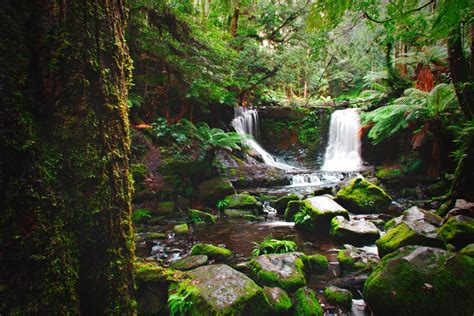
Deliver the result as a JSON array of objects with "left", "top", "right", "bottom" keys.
[{"left": 251, "top": 253, "right": 306, "bottom": 292}]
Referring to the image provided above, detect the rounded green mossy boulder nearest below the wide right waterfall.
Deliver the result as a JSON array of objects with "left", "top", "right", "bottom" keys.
[{"left": 336, "top": 178, "right": 392, "bottom": 214}]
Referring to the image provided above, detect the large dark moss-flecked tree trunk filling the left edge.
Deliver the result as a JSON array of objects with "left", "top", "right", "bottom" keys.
[{"left": 0, "top": 0, "right": 135, "bottom": 315}]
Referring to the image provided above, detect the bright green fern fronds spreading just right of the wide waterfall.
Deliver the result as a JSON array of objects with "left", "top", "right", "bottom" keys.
[{"left": 362, "top": 83, "right": 457, "bottom": 144}]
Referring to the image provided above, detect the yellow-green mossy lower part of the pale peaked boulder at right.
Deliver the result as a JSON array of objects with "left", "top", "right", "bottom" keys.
[{"left": 375, "top": 223, "right": 442, "bottom": 258}]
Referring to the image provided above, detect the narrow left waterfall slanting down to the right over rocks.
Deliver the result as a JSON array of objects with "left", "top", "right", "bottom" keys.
[{"left": 231, "top": 106, "right": 298, "bottom": 171}]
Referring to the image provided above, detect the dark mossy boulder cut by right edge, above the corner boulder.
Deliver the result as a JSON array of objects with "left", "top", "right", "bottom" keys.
[{"left": 439, "top": 215, "right": 474, "bottom": 249}]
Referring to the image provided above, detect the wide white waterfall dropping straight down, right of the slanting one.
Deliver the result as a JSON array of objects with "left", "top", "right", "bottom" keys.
[{"left": 321, "top": 109, "right": 362, "bottom": 172}]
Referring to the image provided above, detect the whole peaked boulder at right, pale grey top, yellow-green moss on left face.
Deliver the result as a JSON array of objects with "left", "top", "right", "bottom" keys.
[{"left": 375, "top": 207, "right": 443, "bottom": 257}]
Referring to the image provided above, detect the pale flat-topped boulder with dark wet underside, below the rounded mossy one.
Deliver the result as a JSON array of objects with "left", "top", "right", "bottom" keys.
[{"left": 331, "top": 216, "right": 380, "bottom": 246}]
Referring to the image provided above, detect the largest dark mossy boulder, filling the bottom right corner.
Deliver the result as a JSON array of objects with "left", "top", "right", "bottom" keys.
[{"left": 364, "top": 246, "right": 474, "bottom": 315}]
